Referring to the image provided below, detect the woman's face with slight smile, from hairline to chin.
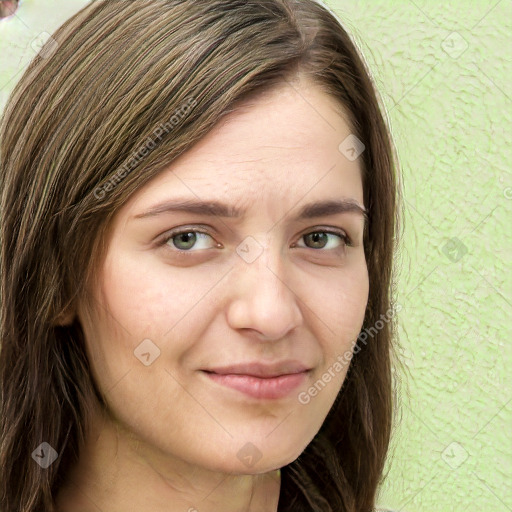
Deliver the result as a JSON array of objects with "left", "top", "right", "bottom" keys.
[{"left": 79, "top": 77, "right": 368, "bottom": 474}]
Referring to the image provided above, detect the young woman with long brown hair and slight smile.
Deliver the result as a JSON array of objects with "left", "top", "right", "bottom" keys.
[{"left": 0, "top": 0, "right": 398, "bottom": 512}]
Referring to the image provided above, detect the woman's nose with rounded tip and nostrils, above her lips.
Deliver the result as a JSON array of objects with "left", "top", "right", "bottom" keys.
[{"left": 227, "top": 242, "right": 303, "bottom": 341}]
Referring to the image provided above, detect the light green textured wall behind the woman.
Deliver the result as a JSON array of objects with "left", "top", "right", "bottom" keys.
[{"left": 0, "top": 0, "right": 512, "bottom": 512}]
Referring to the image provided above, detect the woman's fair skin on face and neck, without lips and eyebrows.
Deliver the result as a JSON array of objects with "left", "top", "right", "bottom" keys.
[{"left": 57, "top": 78, "right": 369, "bottom": 512}]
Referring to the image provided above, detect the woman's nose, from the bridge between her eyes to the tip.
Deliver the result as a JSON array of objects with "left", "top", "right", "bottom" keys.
[{"left": 229, "top": 234, "right": 302, "bottom": 340}]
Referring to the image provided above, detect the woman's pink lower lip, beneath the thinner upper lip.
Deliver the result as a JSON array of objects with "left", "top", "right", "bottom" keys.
[{"left": 204, "top": 372, "right": 307, "bottom": 399}]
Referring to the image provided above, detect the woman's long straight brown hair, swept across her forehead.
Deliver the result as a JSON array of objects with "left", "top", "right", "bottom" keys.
[{"left": 0, "top": 0, "right": 400, "bottom": 512}]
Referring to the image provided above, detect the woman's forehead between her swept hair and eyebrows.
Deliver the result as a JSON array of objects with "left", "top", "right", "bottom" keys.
[{"left": 124, "top": 82, "right": 363, "bottom": 219}]
